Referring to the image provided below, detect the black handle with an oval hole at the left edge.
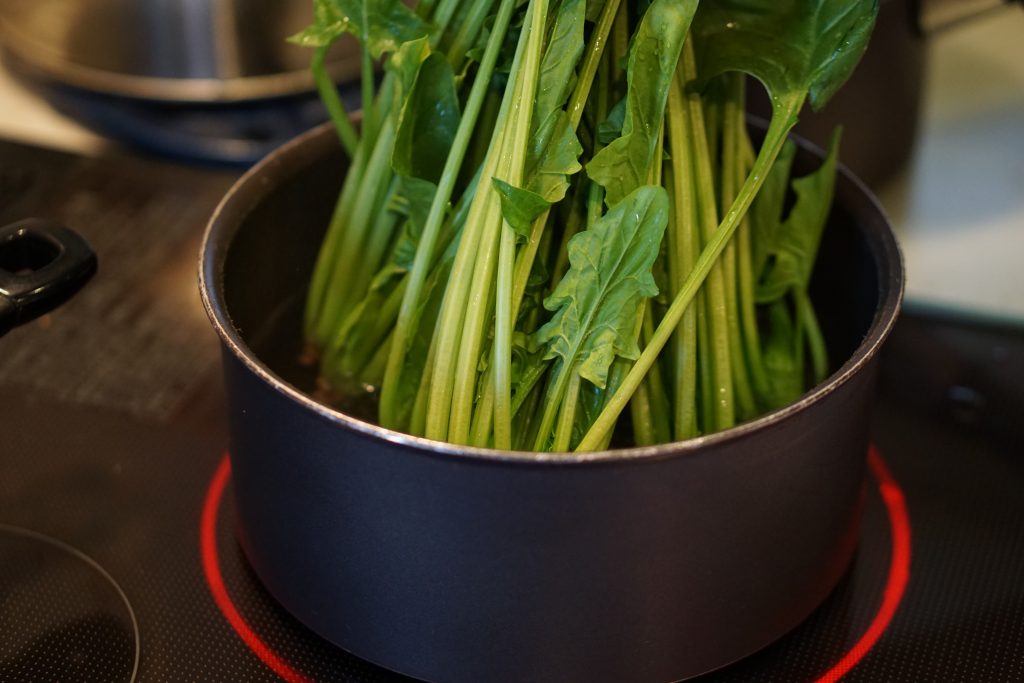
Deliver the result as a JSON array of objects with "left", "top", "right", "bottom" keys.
[{"left": 0, "top": 218, "right": 97, "bottom": 335}]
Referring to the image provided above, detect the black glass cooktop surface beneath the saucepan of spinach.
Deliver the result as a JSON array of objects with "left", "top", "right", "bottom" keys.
[{"left": 0, "top": 136, "right": 1024, "bottom": 683}]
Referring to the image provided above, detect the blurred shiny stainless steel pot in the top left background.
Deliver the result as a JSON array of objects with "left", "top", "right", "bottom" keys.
[{"left": 0, "top": 0, "right": 359, "bottom": 102}]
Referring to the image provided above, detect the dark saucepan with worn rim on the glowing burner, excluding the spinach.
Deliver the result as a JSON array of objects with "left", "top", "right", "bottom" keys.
[{"left": 201, "top": 128, "right": 902, "bottom": 682}]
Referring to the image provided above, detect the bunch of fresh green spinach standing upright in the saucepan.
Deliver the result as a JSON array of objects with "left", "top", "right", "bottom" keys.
[{"left": 293, "top": 0, "right": 878, "bottom": 452}]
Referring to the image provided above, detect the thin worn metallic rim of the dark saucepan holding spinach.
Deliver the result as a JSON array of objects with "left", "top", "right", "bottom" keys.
[{"left": 199, "top": 123, "right": 904, "bottom": 466}]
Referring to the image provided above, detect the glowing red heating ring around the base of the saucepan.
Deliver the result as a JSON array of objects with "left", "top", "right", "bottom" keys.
[{"left": 200, "top": 446, "right": 910, "bottom": 683}]
